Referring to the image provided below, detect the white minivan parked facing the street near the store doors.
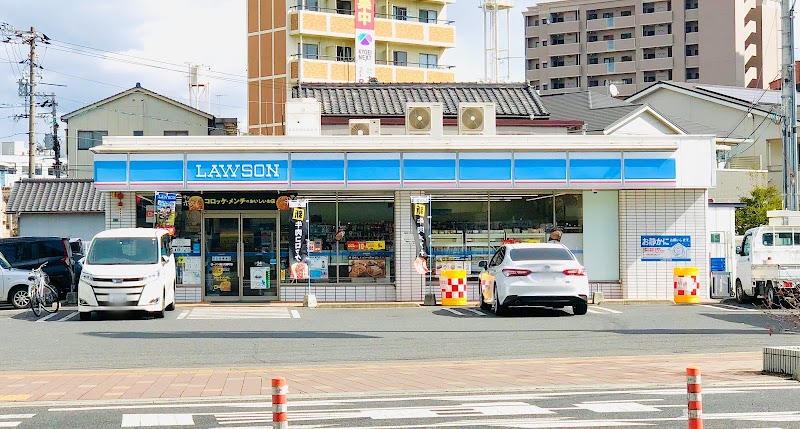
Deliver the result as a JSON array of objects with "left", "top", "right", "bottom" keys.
[{"left": 78, "top": 228, "right": 175, "bottom": 320}]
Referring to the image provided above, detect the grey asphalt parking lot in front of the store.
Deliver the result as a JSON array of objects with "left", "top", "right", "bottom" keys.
[{"left": 0, "top": 304, "right": 800, "bottom": 371}]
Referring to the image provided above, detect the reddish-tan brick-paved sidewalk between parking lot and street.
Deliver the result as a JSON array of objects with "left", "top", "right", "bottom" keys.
[{"left": 0, "top": 352, "right": 776, "bottom": 402}]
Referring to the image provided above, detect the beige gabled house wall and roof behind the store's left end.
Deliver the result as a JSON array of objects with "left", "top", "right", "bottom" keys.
[{"left": 61, "top": 83, "right": 217, "bottom": 179}]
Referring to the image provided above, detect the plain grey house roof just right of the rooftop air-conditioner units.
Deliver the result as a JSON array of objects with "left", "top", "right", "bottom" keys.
[{"left": 542, "top": 91, "right": 642, "bottom": 132}]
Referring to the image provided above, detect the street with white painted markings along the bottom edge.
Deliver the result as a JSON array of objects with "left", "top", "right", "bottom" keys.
[{"left": 0, "top": 381, "right": 800, "bottom": 429}]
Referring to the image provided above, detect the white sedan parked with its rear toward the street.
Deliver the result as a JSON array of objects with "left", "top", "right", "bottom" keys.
[{"left": 480, "top": 243, "right": 589, "bottom": 316}]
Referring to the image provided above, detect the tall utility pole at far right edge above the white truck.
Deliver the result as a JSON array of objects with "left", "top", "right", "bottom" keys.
[{"left": 781, "top": 0, "right": 798, "bottom": 210}]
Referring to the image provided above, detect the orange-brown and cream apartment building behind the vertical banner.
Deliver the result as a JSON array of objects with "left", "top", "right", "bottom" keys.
[{"left": 247, "top": 0, "right": 456, "bottom": 135}]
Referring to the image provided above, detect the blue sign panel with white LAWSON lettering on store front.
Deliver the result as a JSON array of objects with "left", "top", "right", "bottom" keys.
[{"left": 188, "top": 161, "right": 287, "bottom": 182}]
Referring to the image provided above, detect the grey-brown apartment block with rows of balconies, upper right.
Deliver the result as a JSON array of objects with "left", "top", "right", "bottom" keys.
[{"left": 523, "top": 0, "right": 781, "bottom": 96}]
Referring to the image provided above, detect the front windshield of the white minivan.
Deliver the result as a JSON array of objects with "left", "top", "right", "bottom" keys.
[{"left": 87, "top": 237, "right": 158, "bottom": 265}]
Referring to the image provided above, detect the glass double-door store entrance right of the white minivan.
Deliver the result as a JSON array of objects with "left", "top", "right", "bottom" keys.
[{"left": 203, "top": 212, "right": 279, "bottom": 301}]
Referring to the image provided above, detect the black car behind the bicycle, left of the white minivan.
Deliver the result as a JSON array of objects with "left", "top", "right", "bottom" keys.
[{"left": 0, "top": 237, "right": 75, "bottom": 299}]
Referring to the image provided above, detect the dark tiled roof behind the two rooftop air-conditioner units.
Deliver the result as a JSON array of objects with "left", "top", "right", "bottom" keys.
[{"left": 292, "top": 83, "right": 549, "bottom": 119}]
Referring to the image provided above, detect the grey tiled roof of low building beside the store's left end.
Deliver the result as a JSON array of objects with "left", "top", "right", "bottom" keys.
[{"left": 6, "top": 179, "right": 106, "bottom": 213}]
